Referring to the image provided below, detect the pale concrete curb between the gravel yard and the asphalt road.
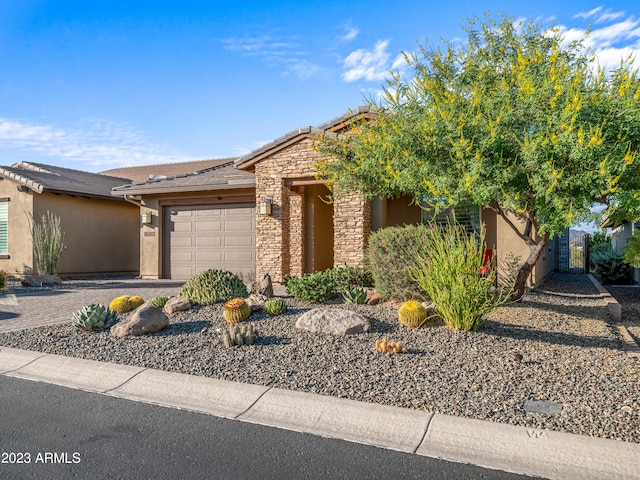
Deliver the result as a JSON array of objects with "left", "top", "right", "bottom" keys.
[{"left": 0, "top": 347, "right": 640, "bottom": 480}]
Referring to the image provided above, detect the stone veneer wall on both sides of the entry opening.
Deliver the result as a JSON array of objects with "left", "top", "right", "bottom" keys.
[{"left": 255, "top": 138, "right": 371, "bottom": 283}]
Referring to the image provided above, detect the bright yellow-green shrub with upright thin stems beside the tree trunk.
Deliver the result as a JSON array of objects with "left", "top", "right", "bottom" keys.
[{"left": 412, "top": 225, "right": 511, "bottom": 331}]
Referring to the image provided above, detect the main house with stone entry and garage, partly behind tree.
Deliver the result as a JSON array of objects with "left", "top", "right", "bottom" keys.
[{"left": 112, "top": 107, "right": 555, "bottom": 284}]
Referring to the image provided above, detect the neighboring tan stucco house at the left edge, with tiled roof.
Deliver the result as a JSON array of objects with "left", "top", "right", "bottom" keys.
[{"left": 0, "top": 162, "right": 140, "bottom": 275}]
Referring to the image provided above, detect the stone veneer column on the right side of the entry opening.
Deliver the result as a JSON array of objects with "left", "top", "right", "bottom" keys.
[{"left": 333, "top": 192, "right": 371, "bottom": 268}]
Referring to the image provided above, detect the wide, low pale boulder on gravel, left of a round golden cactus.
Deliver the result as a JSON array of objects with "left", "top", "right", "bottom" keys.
[{"left": 296, "top": 308, "right": 371, "bottom": 335}]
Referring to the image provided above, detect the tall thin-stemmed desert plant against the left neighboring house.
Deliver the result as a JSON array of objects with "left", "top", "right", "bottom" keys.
[{"left": 29, "top": 210, "right": 64, "bottom": 275}]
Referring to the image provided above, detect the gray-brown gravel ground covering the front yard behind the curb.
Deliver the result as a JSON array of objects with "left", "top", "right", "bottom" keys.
[{"left": 0, "top": 274, "right": 640, "bottom": 443}]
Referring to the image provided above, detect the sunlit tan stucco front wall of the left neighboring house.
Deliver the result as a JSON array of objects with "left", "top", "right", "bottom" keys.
[{"left": 0, "top": 179, "right": 37, "bottom": 275}]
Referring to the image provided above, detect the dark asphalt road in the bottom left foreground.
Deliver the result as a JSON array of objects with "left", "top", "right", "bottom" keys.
[{"left": 0, "top": 376, "right": 530, "bottom": 480}]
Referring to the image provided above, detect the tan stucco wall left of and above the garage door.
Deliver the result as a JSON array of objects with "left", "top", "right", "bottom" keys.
[{"left": 136, "top": 189, "right": 255, "bottom": 279}]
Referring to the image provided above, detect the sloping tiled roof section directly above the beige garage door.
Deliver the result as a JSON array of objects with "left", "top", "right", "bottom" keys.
[{"left": 112, "top": 160, "right": 256, "bottom": 195}]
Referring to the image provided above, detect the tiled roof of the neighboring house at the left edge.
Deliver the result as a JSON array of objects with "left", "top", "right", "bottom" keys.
[{"left": 0, "top": 162, "right": 131, "bottom": 200}]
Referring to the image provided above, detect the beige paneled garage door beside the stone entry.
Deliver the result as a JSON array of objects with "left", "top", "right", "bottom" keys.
[{"left": 163, "top": 203, "right": 256, "bottom": 281}]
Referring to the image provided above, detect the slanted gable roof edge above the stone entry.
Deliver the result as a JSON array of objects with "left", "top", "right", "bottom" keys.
[{"left": 234, "top": 107, "right": 375, "bottom": 170}]
